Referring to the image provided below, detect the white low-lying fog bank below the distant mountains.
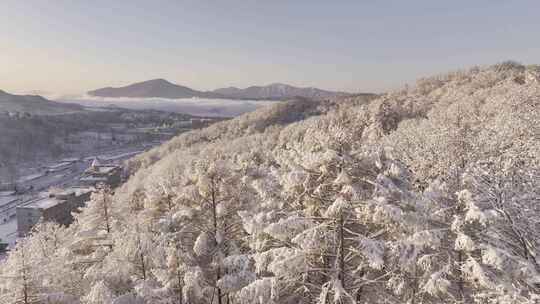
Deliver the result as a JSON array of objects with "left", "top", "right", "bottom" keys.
[{"left": 57, "top": 97, "right": 276, "bottom": 117}]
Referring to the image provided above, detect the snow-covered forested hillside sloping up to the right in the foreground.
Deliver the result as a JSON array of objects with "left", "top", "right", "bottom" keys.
[{"left": 0, "top": 62, "right": 540, "bottom": 304}]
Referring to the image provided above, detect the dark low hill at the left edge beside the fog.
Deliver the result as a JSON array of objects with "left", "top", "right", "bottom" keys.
[{"left": 0, "top": 90, "right": 84, "bottom": 115}]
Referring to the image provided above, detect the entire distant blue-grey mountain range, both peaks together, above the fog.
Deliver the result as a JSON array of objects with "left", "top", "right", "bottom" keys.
[{"left": 88, "top": 79, "right": 349, "bottom": 100}]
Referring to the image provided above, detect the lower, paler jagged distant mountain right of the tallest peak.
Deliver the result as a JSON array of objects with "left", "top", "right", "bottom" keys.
[{"left": 213, "top": 83, "right": 349, "bottom": 100}]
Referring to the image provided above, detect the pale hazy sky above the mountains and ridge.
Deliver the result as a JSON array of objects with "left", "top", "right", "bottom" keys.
[{"left": 0, "top": 0, "right": 540, "bottom": 94}]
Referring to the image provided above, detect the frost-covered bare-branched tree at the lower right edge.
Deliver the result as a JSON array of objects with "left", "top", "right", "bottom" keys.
[{"left": 456, "top": 158, "right": 540, "bottom": 303}]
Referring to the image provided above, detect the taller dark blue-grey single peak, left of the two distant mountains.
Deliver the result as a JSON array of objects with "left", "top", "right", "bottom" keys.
[{"left": 88, "top": 79, "right": 223, "bottom": 98}]
